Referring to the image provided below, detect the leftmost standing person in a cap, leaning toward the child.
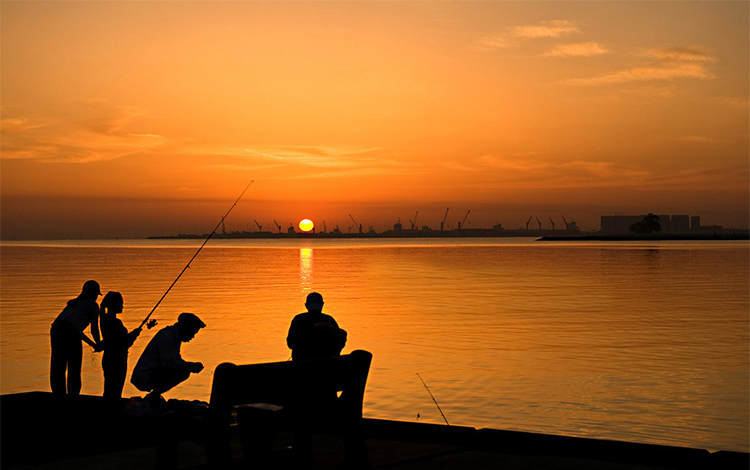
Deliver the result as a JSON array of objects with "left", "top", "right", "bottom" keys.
[{"left": 49, "top": 281, "right": 102, "bottom": 397}]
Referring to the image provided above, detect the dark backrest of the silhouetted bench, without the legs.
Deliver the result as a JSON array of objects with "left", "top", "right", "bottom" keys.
[{"left": 210, "top": 350, "right": 372, "bottom": 419}]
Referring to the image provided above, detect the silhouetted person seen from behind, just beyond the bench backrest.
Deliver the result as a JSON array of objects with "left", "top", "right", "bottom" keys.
[{"left": 286, "top": 292, "right": 346, "bottom": 361}]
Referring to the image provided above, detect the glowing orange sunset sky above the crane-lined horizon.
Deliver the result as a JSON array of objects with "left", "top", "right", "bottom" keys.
[{"left": 0, "top": 1, "right": 750, "bottom": 239}]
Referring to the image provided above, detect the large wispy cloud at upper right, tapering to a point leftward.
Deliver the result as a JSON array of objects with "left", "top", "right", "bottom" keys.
[{"left": 569, "top": 46, "right": 715, "bottom": 86}]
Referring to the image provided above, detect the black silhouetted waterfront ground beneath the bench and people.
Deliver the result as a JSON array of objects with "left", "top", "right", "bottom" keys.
[{"left": 0, "top": 392, "right": 750, "bottom": 470}]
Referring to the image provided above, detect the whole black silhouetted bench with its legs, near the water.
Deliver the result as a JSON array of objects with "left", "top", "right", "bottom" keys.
[{"left": 157, "top": 350, "right": 372, "bottom": 469}]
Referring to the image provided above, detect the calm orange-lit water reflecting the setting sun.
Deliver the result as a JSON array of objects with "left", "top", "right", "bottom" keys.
[{"left": 0, "top": 239, "right": 750, "bottom": 452}]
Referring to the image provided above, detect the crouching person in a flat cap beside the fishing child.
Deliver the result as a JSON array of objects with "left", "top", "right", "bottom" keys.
[{"left": 130, "top": 313, "right": 206, "bottom": 401}]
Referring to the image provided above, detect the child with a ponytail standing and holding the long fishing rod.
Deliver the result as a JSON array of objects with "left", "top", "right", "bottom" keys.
[{"left": 100, "top": 291, "right": 141, "bottom": 401}]
